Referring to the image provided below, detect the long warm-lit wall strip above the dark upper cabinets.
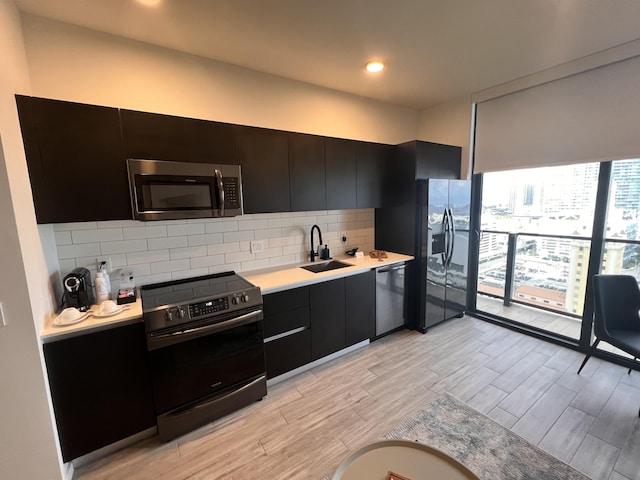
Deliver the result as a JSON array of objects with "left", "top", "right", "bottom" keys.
[{"left": 23, "top": 15, "right": 419, "bottom": 143}]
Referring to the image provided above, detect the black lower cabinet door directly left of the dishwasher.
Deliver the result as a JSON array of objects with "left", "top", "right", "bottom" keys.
[{"left": 345, "top": 270, "right": 376, "bottom": 346}]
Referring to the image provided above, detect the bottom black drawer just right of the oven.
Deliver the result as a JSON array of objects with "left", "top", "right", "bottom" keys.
[{"left": 264, "top": 329, "right": 311, "bottom": 378}]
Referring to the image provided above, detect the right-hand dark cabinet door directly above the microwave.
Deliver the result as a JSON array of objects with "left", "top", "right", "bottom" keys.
[{"left": 185, "top": 118, "right": 240, "bottom": 165}]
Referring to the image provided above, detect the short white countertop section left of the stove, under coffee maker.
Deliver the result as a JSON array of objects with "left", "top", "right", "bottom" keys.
[{"left": 40, "top": 295, "right": 142, "bottom": 343}]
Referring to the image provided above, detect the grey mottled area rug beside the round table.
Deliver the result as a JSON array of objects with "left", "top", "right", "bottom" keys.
[{"left": 384, "top": 394, "right": 588, "bottom": 480}]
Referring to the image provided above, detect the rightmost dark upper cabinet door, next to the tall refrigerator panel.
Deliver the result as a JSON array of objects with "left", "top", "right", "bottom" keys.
[{"left": 356, "top": 142, "right": 393, "bottom": 208}]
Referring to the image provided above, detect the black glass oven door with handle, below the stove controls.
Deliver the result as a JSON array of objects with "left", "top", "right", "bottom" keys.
[{"left": 147, "top": 309, "right": 265, "bottom": 415}]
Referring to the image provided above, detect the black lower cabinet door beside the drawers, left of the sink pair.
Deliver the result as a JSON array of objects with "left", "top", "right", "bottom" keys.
[{"left": 309, "top": 278, "right": 346, "bottom": 360}]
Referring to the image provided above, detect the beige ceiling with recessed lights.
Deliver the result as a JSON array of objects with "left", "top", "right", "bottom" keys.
[{"left": 14, "top": 0, "right": 640, "bottom": 110}]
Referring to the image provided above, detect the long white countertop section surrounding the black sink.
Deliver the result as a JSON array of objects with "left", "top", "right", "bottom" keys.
[{"left": 240, "top": 252, "right": 413, "bottom": 295}]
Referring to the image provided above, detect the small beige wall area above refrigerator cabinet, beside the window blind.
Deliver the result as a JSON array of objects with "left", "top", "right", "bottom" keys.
[{"left": 418, "top": 97, "right": 471, "bottom": 178}]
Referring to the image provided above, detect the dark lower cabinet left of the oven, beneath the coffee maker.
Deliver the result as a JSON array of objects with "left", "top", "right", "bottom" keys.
[{"left": 43, "top": 323, "right": 156, "bottom": 462}]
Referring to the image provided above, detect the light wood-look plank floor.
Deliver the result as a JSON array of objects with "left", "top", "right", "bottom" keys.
[{"left": 74, "top": 316, "right": 640, "bottom": 480}]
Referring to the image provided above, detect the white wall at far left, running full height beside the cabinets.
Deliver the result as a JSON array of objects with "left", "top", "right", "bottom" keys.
[{"left": 0, "top": 0, "right": 62, "bottom": 479}]
